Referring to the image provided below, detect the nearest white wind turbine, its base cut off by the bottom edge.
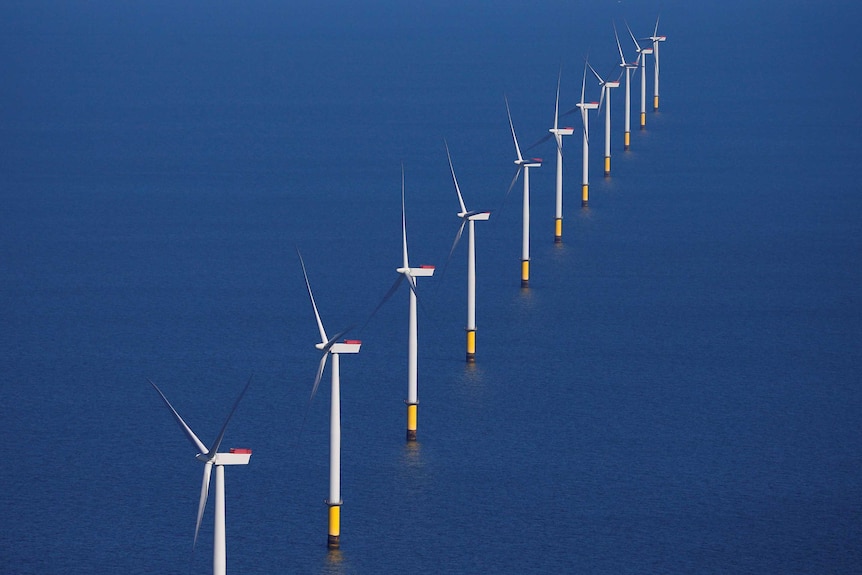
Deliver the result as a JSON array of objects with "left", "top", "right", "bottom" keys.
[{"left": 147, "top": 377, "right": 251, "bottom": 575}]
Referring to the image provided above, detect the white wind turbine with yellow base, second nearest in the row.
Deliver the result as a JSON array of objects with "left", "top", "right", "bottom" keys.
[{"left": 296, "top": 250, "right": 362, "bottom": 549}]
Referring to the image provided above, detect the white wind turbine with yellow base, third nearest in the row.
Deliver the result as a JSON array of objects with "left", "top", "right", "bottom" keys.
[{"left": 390, "top": 166, "right": 434, "bottom": 441}]
